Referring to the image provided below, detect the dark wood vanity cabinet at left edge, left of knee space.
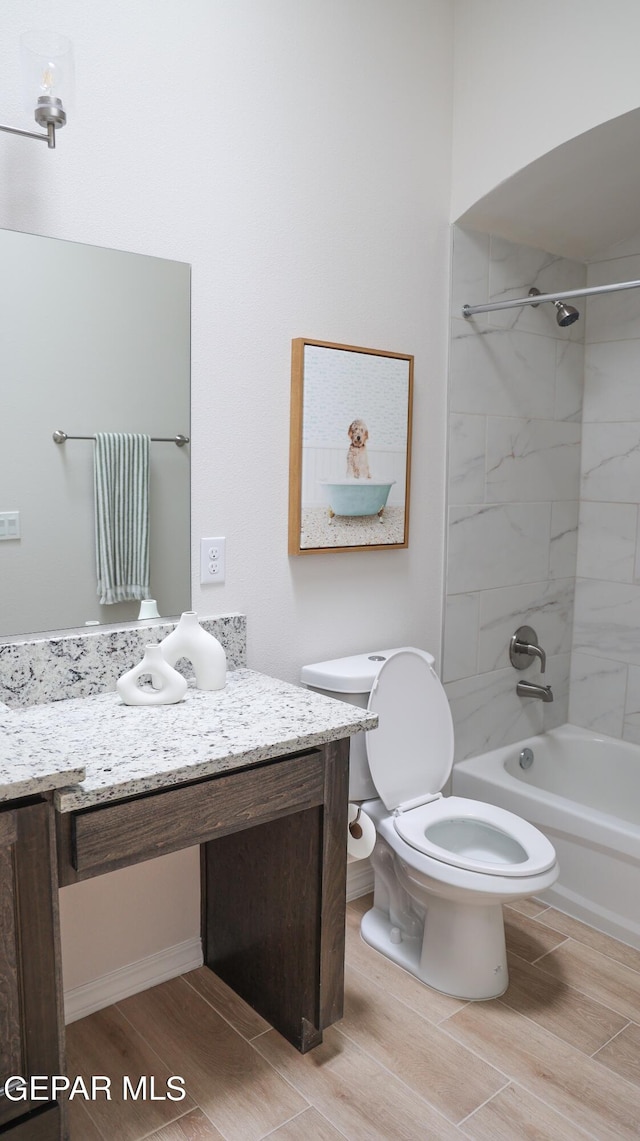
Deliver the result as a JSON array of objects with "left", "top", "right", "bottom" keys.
[{"left": 0, "top": 796, "right": 64, "bottom": 1141}]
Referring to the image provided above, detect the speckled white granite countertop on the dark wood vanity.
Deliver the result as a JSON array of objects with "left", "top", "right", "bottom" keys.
[{"left": 0, "top": 669, "right": 378, "bottom": 812}]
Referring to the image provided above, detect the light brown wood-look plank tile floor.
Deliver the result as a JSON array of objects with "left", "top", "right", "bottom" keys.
[{"left": 67, "top": 897, "right": 640, "bottom": 1141}]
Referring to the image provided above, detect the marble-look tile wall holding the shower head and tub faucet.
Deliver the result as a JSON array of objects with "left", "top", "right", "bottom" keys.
[{"left": 443, "top": 227, "right": 584, "bottom": 760}]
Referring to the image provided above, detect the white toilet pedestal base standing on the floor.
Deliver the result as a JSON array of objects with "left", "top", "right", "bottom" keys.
[{"left": 360, "top": 897, "right": 509, "bottom": 1002}]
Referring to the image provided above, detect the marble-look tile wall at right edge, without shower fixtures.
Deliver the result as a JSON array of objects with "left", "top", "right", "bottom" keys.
[{"left": 569, "top": 235, "right": 640, "bottom": 744}]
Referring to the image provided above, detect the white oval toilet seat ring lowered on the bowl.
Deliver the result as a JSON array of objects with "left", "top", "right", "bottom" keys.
[{"left": 394, "top": 796, "right": 556, "bottom": 879}]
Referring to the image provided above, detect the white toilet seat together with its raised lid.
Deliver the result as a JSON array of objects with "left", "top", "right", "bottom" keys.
[{"left": 365, "top": 649, "right": 556, "bottom": 880}]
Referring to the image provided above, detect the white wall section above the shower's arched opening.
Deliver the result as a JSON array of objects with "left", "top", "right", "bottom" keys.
[{"left": 451, "top": 0, "right": 640, "bottom": 219}]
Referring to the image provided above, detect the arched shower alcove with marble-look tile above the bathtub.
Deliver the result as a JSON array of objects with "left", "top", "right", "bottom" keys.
[{"left": 443, "top": 110, "right": 640, "bottom": 760}]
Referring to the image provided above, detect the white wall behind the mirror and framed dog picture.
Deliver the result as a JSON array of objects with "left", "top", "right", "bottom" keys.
[{"left": 0, "top": 0, "right": 453, "bottom": 986}]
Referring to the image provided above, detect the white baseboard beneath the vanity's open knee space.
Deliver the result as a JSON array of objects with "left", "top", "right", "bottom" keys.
[{"left": 64, "top": 938, "right": 203, "bottom": 1025}]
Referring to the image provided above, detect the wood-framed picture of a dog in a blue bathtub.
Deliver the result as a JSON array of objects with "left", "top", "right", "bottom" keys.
[{"left": 289, "top": 338, "right": 413, "bottom": 555}]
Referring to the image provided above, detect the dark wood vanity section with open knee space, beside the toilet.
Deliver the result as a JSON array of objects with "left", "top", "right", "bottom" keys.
[{"left": 57, "top": 739, "right": 349, "bottom": 1053}]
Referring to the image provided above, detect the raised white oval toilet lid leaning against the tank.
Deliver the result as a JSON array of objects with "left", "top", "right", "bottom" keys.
[{"left": 365, "top": 649, "right": 453, "bottom": 811}]
